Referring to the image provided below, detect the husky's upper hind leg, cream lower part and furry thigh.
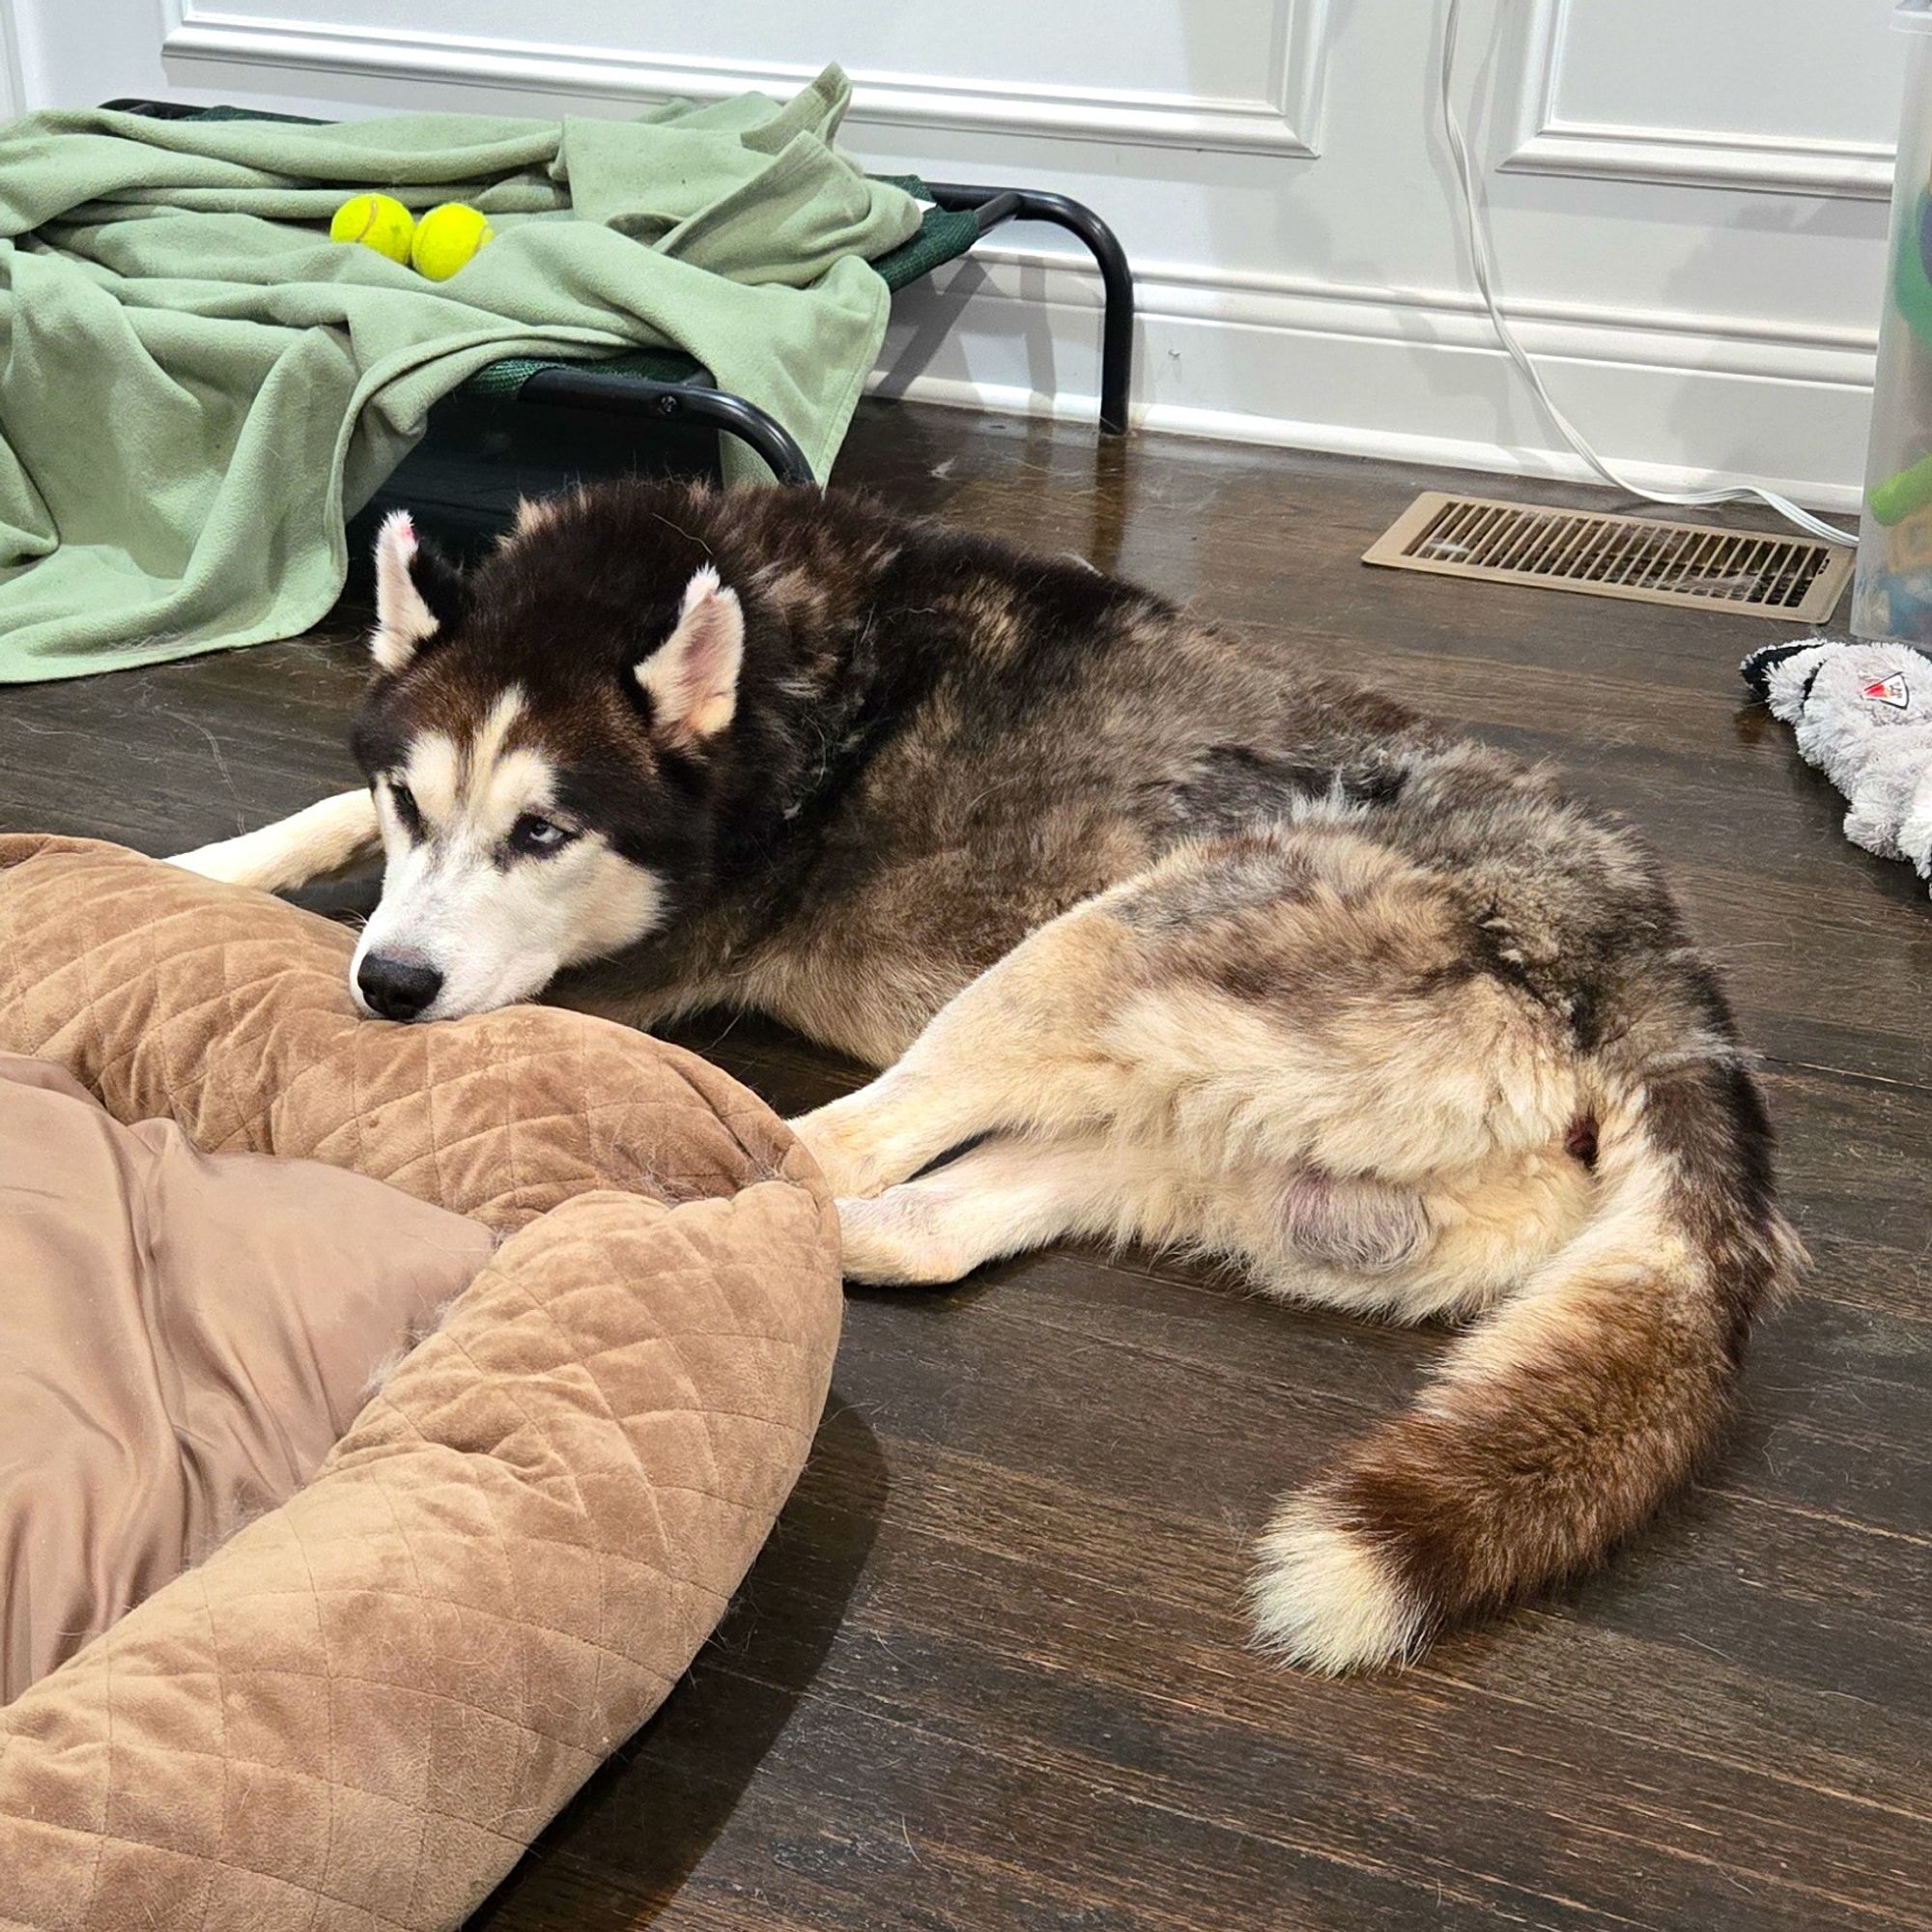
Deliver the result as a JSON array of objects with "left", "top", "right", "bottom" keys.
[{"left": 794, "top": 829, "right": 1575, "bottom": 1219}]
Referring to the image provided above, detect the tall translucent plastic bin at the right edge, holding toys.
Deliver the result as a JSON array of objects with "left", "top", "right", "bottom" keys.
[{"left": 1851, "top": 0, "right": 1932, "bottom": 645}]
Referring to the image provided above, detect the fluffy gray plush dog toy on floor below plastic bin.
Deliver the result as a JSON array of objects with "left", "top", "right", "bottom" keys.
[{"left": 1739, "top": 638, "right": 1932, "bottom": 883}]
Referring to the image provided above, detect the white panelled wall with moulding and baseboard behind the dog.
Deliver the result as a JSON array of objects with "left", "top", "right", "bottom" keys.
[{"left": 0, "top": 0, "right": 1907, "bottom": 504}]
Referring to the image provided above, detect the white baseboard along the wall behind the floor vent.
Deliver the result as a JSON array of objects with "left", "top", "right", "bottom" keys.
[{"left": 873, "top": 249, "right": 1874, "bottom": 510}]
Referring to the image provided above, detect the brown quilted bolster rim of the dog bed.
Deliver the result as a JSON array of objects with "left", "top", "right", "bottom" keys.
[{"left": 0, "top": 837, "right": 838, "bottom": 1932}]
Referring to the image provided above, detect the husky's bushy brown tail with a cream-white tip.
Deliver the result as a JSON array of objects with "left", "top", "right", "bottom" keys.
[{"left": 1254, "top": 1041, "right": 1803, "bottom": 1671}]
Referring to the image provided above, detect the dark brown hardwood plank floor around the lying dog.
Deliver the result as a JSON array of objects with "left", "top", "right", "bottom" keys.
[{"left": 0, "top": 404, "right": 1932, "bottom": 1932}]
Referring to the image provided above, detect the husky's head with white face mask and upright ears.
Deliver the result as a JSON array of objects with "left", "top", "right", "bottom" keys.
[{"left": 350, "top": 498, "right": 746, "bottom": 1020}]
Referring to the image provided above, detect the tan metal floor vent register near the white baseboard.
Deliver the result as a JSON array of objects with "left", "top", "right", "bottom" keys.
[{"left": 1362, "top": 491, "right": 1851, "bottom": 624}]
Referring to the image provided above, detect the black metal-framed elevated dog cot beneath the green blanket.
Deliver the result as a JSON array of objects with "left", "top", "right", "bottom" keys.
[{"left": 106, "top": 99, "right": 1134, "bottom": 506}]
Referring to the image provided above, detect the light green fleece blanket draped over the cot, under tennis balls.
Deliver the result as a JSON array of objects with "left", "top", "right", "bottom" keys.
[{"left": 0, "top": 68, "right": 920, "bottom": 682}]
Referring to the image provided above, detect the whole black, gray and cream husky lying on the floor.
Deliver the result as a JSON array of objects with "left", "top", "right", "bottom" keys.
[{"left": 178, "top": 483, "right": 1801, "bottom": 1671}]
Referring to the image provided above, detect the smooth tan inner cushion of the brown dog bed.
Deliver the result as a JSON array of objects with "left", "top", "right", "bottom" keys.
[{"left": 0, "top": 1053, "right": 495, "bottom": 1702}]
